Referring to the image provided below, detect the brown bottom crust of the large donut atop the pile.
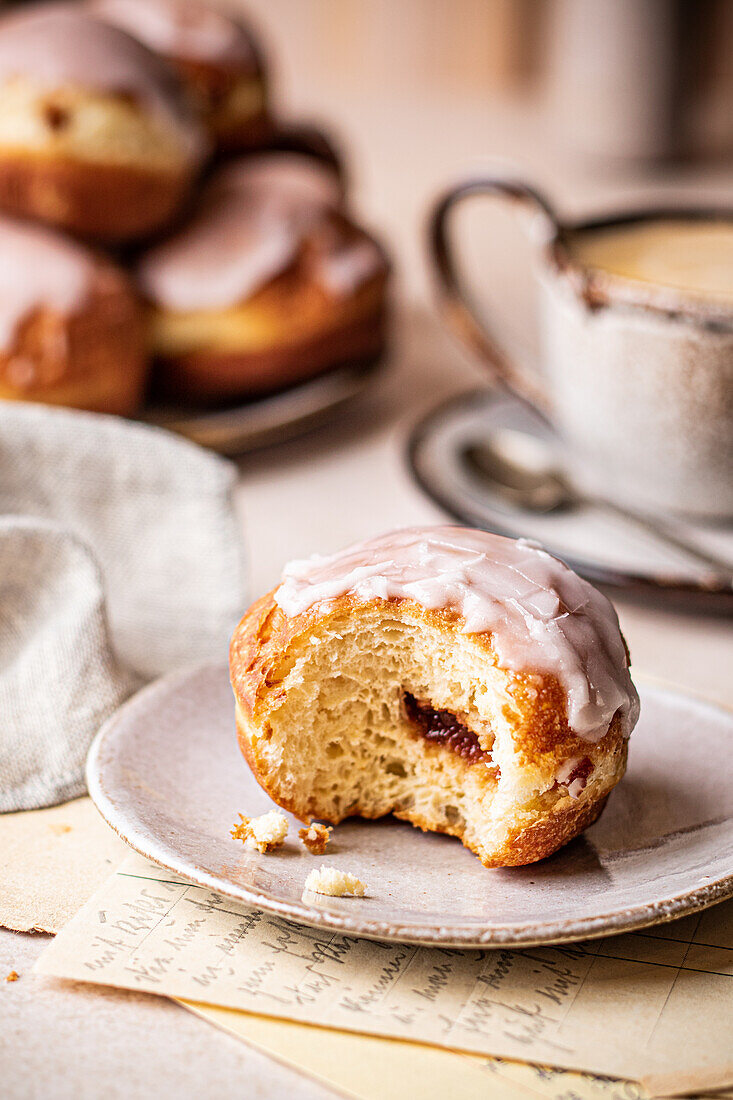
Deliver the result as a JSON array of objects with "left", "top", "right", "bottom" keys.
[{"left": 0, "top": 151, "right": 192, "bottom": 242}]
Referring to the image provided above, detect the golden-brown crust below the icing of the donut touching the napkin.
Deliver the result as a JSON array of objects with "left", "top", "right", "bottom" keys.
[{"left": 0, "top": 263, "right": 147, "bottom": 416}]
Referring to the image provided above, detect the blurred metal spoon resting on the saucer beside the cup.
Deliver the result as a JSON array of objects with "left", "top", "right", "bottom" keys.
[{"left": 462, "top": 431, "right": 733, "bottom": 582}]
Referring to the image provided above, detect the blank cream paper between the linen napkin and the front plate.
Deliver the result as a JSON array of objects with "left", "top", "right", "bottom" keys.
[{"left": 0, "top": 799, "right": 130, "bottom": 932}]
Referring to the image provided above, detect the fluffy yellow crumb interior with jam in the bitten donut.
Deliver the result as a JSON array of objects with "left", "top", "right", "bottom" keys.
[{"left": 238, "top": 608, "right": 623, "bottom": 866}]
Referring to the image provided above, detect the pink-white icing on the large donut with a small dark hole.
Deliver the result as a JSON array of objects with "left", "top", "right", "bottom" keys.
[{"left": 0, "top": 3, "right": 204, "bottom": 157}]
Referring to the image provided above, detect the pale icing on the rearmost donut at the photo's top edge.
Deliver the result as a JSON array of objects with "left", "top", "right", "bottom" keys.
[{"left": 90, "top": 0, "right": 259, "bottom": 72}]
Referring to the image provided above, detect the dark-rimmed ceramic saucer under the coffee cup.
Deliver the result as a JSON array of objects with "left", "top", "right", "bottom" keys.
[{"left": 408, "top": 388, "right": 733, "bottom": 615}]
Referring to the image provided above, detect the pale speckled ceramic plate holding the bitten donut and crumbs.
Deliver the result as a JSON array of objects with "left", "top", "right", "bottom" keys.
[{"left": 87, "top": 667, "right": 733, "bottom": 947}]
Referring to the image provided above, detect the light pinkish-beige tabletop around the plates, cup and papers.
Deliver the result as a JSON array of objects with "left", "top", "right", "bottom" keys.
[{"left": 5, "top": 51, "right": 733, "bottom": 1100}]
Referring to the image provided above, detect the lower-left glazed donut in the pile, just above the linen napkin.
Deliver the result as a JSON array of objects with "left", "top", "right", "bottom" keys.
[{"left": 0, "top": 217, "right": 146, "bottom": 414}]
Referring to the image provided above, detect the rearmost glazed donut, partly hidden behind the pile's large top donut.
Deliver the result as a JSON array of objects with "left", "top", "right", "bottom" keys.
[{"left": 90, "top": 0, "right": 273, "bottom": 152}]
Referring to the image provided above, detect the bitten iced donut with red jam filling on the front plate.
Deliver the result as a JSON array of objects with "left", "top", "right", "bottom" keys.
[{"left": 230, "top": 527, "right": 638, "bottom": 867}]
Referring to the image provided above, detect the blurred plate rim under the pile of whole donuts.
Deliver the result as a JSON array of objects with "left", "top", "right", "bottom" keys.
[{"left": 143, "top": 360, "right": 381, "bottom": 455}]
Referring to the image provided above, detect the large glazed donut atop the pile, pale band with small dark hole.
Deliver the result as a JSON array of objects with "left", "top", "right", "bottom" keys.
[{"left": 0, "top": 4, "right": 206, "bottom": 241}]
